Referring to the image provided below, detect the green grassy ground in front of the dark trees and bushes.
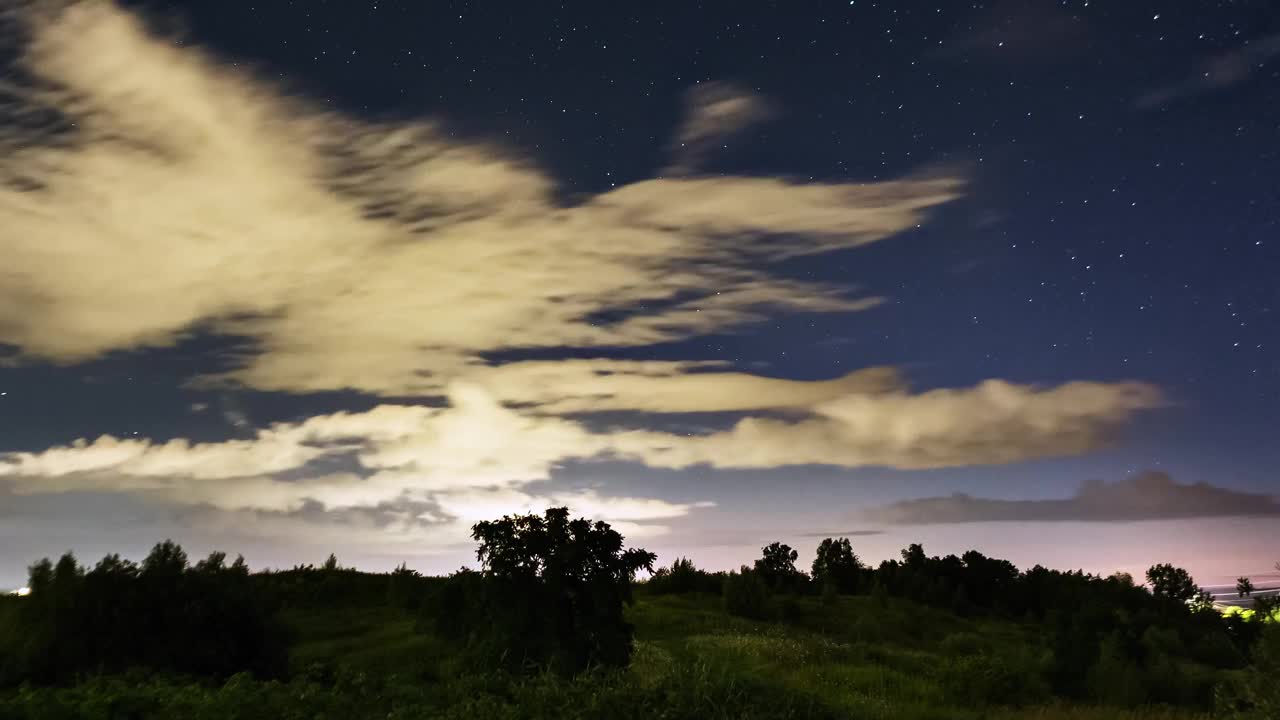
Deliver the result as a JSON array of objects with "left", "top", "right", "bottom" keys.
[{"left": 0, "top": 589, "right": 1223, "bottom": 720}]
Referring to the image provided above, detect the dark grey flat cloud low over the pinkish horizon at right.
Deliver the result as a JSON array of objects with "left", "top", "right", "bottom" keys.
[{"left": 865, "top": 471, "right": 1280, "bottom": 525}]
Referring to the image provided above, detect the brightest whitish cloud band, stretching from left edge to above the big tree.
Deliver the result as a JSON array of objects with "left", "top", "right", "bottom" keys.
[{"left": 0, "top": 386, "right": 607, "bottom": 511}]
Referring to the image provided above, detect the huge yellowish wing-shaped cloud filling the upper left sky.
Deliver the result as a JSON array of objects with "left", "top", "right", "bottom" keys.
[{"left": 0, "top": 1, "right": 961, "bottom": 395}]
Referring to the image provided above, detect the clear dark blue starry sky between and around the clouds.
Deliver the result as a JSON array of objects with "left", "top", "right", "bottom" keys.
[{"left": 0, "top": 0, "right": 1280, "bottom": 579}]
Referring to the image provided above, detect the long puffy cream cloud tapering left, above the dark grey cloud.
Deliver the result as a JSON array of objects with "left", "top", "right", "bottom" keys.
[{"left": 620, "top": 380, "right": 1162, "bottom": 469}]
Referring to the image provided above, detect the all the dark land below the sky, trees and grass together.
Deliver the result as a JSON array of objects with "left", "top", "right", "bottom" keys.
[{"left": 0, "top": 509, "right": 1280, "bottom": 720}]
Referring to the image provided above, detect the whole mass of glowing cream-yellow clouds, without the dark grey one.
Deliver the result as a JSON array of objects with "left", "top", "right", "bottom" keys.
[{"left": 0, "top": 1, "right": 1161, "bottom": 542}]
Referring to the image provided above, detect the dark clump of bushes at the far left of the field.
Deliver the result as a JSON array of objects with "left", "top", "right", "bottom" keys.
[{"left": 0, "top": 541, "right": 287, "bottom": 685}]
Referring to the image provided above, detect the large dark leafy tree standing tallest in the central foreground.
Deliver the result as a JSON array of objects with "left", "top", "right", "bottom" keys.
[{"left": 439, "top": 507, "right": 657, "bottom": 675}]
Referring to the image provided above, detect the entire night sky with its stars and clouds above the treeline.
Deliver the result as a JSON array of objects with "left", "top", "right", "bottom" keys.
[{"left": 0, "top": 0, "right": 1280, "bottom": 587}]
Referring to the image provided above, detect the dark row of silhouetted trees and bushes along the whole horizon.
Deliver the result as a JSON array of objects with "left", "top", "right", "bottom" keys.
[{"left": 0, "top": 507, "right": 1280, "bottom": 707}]
